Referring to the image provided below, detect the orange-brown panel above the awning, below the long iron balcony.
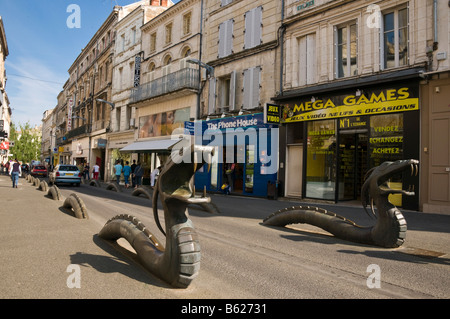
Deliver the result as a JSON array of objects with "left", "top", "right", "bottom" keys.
[{"left": 139, "top": 107, "right": 190, "bottom": 138}]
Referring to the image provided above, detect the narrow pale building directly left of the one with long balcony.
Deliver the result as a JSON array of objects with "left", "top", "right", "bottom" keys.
[{"left": 106, "top": 0, "right": 173, "bottom": 179}]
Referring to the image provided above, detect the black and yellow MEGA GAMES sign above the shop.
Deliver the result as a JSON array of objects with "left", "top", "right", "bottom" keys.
[{"left": 280, "top": 87, "right": 419, "bottom": 123}]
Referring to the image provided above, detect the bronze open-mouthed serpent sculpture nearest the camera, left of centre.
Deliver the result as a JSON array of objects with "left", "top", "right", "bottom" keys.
[{"left": 99, "top": 141, "right": 213, "bottom": 288}]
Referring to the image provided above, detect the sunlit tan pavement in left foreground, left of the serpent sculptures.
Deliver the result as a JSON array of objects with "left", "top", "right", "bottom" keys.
[{"left": 0, "top": 175, "right": 179, "bottom": 299}]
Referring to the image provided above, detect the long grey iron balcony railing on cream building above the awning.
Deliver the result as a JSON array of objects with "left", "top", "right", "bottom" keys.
[{"left": 130, "top": 68, "right": 199, "bottom": 103}]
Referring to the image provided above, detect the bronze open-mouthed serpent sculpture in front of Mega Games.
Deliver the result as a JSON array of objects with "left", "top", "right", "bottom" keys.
[{"left": 263, "top": 159, "right": 419, "bottom": 248}]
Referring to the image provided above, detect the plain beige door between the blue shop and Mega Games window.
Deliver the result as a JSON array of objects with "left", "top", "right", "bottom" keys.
[{"left": 286, "top": 145, "right": 303, "bottom": 197}]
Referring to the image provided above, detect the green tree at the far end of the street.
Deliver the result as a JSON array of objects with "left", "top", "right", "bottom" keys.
[{"left": 9, "top": 122, "right": 41, "bottom": 163}]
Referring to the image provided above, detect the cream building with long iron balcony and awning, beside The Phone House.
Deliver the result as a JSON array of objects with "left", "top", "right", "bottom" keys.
[{"left": 121, "top": 0, "right": 202, "bottom": 183}]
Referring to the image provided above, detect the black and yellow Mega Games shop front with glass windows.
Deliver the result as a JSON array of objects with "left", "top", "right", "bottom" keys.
[{"left": 280, "top": 82, "right": 420, "bottom": 209}]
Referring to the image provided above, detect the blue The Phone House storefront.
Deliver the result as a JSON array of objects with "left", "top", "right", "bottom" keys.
[{"left": 185, "top": 113, "right": 278, "bottom": 197}]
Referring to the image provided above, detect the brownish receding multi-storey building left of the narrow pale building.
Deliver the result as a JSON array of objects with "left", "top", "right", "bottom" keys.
[{"left": 64, "top": 6, "right": 121, "bottom": 179}]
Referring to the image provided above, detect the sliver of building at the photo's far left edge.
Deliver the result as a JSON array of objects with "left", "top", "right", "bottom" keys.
[{"left": 0, "top": 16, "right": 11, "bottom": 163}]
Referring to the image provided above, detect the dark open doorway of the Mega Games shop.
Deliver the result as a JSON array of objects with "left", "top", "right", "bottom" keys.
[{"left": 338, "top": 130, "right": 368, "bottom": 200}]
